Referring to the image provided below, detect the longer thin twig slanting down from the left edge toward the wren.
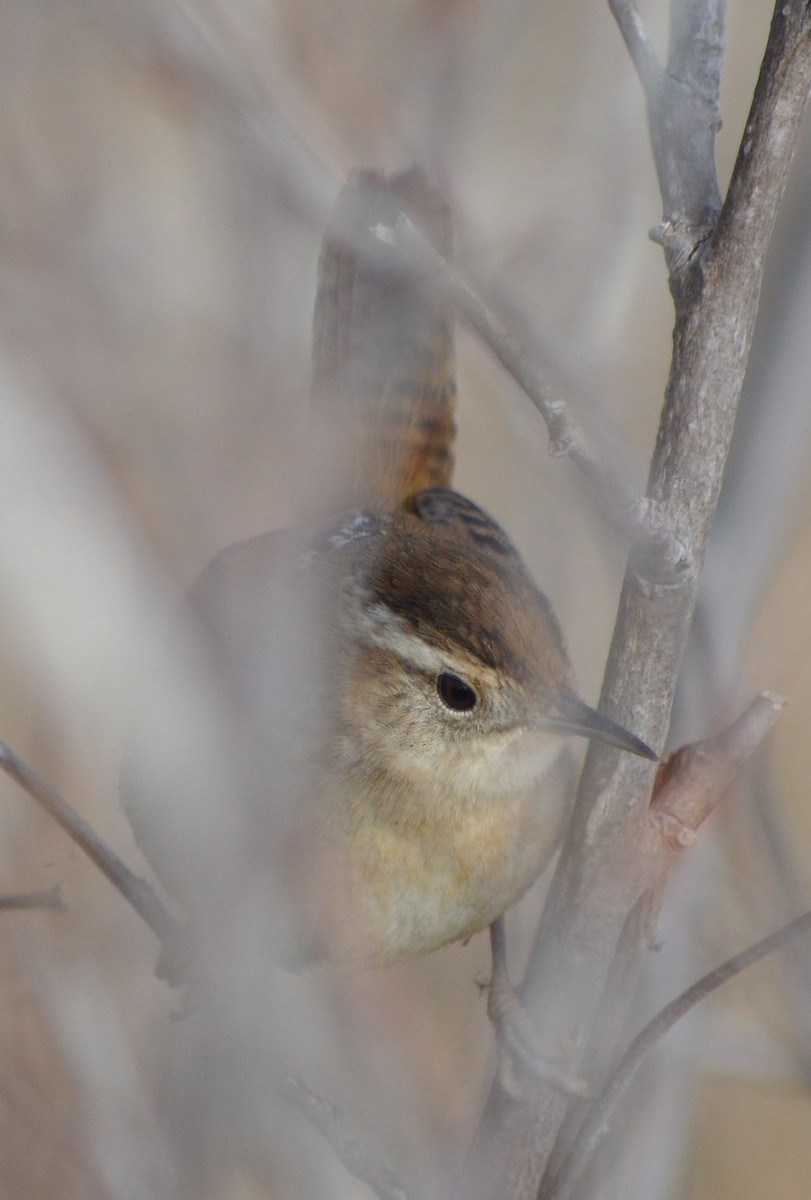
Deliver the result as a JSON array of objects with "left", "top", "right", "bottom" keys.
[{"left": 0, "top": 742, "right": 180, "bottom": 947}]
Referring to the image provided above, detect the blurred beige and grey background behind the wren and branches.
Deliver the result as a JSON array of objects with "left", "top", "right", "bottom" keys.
[{"left": 0, "top": 0, "right": 811, "bottom": 1200}]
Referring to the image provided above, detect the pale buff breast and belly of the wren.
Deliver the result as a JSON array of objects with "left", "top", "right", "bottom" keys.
[{"left": 320, "top": 744, "right": 572, "bottom": 962}]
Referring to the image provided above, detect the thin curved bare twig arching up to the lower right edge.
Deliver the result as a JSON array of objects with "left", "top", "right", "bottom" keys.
[{"left": 543, "top": 912, "right": 811, "bottom": 1200}]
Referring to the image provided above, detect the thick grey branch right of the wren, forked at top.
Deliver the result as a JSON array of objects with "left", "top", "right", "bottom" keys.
[{"left": 465, "top": 0, "right": 811, "bottom": 1198}]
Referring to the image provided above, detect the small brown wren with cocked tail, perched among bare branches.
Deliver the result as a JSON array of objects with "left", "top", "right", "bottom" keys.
[{"left": 134, "top": 170, "right": 653, "bottom": 962}]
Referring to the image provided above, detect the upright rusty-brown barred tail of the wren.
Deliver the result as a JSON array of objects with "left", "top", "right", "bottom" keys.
[{"left": 313, "top": 168, "right": 456, "bottom": 509}]
